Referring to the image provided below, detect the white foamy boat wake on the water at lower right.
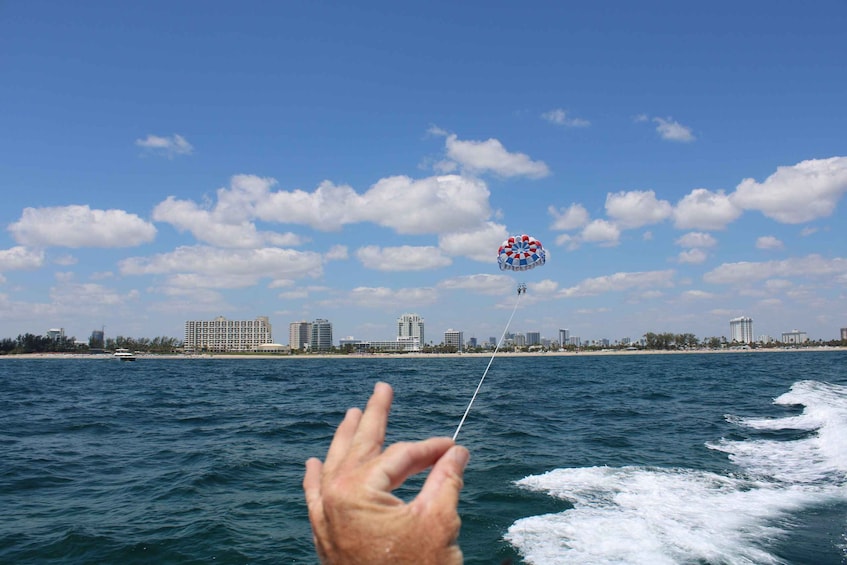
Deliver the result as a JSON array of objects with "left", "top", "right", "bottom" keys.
[{"left": 505, "top": 381, "right": 847, "bottom": 565}]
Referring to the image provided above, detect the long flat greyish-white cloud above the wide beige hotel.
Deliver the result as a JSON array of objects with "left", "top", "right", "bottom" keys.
[{"left": 118, "top": 245, "right": 323, "bottom": 287}]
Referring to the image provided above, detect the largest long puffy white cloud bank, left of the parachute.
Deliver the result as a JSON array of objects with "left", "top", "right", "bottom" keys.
[{"left": 154, "top": 175, "right": 491, "bottom": 239}]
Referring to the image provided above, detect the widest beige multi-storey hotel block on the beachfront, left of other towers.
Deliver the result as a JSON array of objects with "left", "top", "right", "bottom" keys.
[{"left": 185, "top": 316, "right": 273, "bottom": 353}]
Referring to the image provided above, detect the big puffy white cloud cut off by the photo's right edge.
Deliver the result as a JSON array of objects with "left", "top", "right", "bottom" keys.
[{"left": 732, "top": 157, "right": 847, "bottom": 224}]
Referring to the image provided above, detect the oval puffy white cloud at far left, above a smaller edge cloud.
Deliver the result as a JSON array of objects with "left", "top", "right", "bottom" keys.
[{"left": 8, "top": 205, "right": 156, "bottom": 248}]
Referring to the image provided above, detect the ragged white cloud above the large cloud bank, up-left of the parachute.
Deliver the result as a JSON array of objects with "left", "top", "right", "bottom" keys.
[{"left": 445, "top": 134, "right": 550, "bottom": 178}]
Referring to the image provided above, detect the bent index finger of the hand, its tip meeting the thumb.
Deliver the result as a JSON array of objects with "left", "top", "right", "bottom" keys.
[{"left": 371, "top": 437, "right": 453, "bottom": 492}]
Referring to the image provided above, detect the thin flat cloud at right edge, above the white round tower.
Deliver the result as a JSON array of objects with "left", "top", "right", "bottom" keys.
[{"left": 703, "top": 254, "right": 847, "bottom": 284}]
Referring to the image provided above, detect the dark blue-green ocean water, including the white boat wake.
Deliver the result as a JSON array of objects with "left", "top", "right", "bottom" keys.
[{"left": 0, "top": 351, "right": 847, "bottom": 565}]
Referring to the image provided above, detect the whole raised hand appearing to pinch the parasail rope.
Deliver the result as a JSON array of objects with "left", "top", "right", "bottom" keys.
[{"left": 303, "top": 383, "right": 470, "bottom": 565}]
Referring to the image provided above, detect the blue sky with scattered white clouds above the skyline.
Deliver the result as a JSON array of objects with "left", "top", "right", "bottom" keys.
[{"left": 0, "top": 1, "right": 847, "bottom": 343}]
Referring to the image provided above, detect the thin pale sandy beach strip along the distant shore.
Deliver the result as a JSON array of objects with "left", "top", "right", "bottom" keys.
[{"left": 0, "top": 346, "right": 847, "bottom": 361}]
